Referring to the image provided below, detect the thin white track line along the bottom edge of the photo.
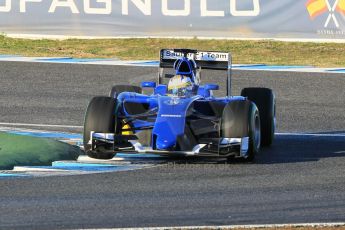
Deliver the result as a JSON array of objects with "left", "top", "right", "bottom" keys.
[{"left": 109, "top": 222, "right": 345, "bottom": 230}]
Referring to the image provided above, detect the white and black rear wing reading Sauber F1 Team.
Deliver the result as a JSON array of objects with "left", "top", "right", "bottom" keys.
[{"left": 158, "top": 49, "right": 232, "bottom": 96}]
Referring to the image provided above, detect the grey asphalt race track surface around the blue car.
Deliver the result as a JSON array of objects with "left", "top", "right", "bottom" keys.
[{"left": 0, "top": 62, "right": 345, "bottom": 229}]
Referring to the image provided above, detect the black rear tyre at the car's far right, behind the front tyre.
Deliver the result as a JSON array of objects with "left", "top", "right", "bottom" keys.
[{"left": 241, "top": 88, "right": 276, "bottom": 146}]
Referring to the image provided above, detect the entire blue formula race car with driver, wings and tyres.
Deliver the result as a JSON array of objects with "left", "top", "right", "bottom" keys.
[{"left": 84, "top": 49, "right": 275, "bottom": 161}]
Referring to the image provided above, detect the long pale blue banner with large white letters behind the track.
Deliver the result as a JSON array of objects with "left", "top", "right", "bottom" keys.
[{"left": 0, "top": 0, "right": 345, "bottom": 39}]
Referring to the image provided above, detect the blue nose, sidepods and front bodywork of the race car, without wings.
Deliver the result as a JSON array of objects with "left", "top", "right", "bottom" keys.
[{"left": 116, "top": 87, "right": 245, "bottom": 151}]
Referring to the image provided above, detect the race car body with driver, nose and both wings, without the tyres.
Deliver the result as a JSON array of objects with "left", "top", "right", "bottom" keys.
[{"left": 91, "top": 49, "right": 246, "bottom": 155}]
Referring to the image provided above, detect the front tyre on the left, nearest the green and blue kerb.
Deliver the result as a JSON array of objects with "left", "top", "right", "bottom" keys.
[{"left": 83, "top": 97, "right": 116, "bottom": 159}]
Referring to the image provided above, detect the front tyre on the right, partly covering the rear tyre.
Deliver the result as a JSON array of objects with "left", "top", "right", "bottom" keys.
[{"left": 221, "top": 100, "right": 261, "bottom": 162}]
